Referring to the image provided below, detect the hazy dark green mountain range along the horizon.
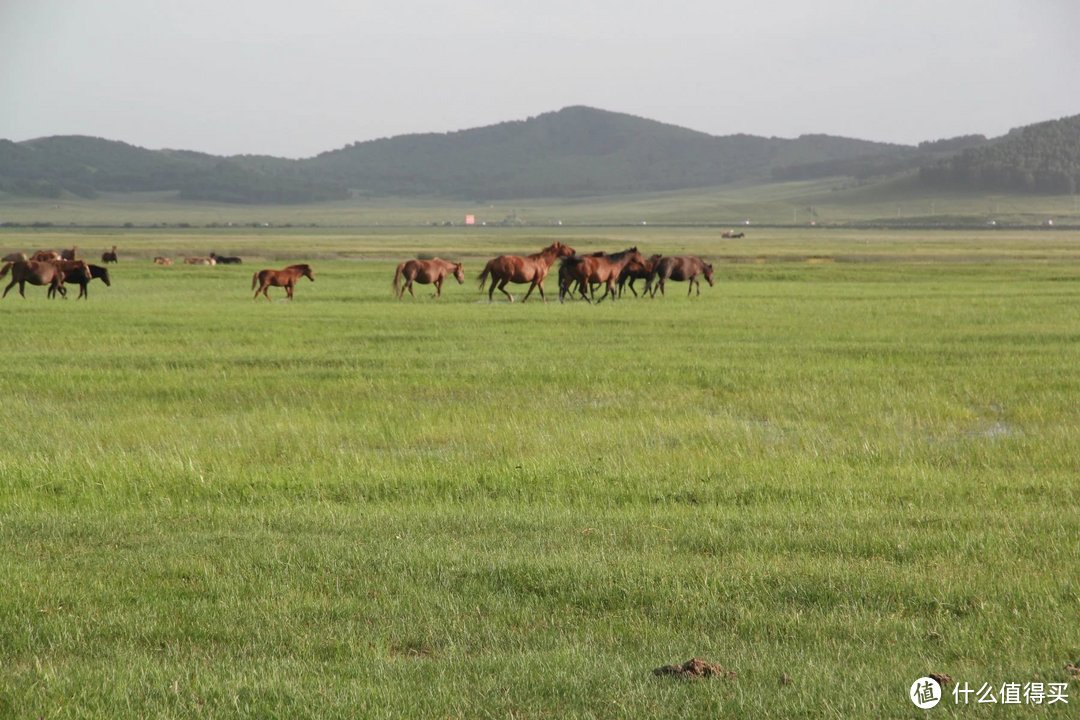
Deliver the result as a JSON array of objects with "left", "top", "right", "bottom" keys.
[{"left": 0, "top": 107, "right": 1080, "bottom": 204}]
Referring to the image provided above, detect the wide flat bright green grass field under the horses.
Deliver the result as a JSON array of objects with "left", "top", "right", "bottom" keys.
[{"left": 0, "top": 228, "right": 1080, "bottom": 719}]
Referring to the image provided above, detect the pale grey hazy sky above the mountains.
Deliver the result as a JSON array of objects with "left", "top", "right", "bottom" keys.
[{"left": 0, "top": 0, "right": 1080, "bottom": 158}]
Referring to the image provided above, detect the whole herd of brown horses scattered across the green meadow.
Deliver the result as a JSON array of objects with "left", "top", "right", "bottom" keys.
[{"left": 6, "top": 242, "right": 714, "bottom": 303}]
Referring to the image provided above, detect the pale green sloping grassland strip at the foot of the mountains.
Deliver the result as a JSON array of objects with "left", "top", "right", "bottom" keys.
[{"left": 6, "top": 176, "right": 1080, "bottom": 227}]
